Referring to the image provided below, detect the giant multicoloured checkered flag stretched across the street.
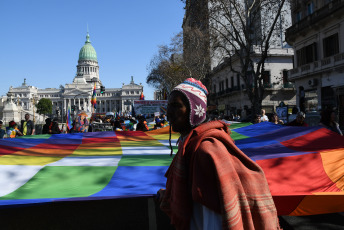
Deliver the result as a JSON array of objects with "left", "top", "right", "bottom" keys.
[{"left": 0, "top": 122, "right": 344, "bottom": 216}]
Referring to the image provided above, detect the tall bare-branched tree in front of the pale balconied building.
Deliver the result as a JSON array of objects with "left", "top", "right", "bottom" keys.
[{"left": 184, "top": 0, "right": 290, "bottom": 113}]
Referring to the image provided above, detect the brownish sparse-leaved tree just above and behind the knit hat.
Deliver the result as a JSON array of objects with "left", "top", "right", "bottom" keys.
[{"left": 147, "top": 28, "right": 209, "bottom": 92}]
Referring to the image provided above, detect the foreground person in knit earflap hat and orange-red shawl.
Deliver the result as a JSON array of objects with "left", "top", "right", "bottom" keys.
[{"left": 158, "top": 78, "right": 279, "bottom": 230}]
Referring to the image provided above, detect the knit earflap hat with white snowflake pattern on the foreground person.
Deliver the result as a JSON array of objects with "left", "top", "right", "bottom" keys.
[{"left": 171, "top": 78, "right": 208, "bottom": 127}]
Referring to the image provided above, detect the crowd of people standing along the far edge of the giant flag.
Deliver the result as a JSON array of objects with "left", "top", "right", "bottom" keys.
[{"left": 0, "top": 100, "right": 343, "bottom": 139}]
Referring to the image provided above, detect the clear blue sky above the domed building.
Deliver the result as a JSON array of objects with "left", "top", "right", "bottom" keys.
[{"left": 0, "top": 0, "right": 184, "bottom": 100}]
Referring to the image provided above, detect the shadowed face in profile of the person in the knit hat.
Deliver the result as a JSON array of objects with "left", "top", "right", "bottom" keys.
[{"left": 167, "top": 92, "right": 191, "bottom": 135}]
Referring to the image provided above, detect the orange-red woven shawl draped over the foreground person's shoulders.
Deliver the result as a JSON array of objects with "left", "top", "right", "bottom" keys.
[{"left": 161, "top": 121, "right": 279, "bottom": 229}]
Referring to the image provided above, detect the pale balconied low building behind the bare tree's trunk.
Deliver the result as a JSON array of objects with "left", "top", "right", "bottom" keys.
[{"left": 209, "top": 48, "right": 296, "bottom": 116}]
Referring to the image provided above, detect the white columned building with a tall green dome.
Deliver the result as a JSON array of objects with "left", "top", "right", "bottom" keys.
[{"left": 2, "top": 32, "right": 143, "bottom": 122}]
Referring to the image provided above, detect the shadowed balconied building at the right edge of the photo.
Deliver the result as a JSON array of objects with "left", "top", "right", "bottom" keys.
[{"left": 286, "top": 0, "right": 344, "bottom": 127}]
